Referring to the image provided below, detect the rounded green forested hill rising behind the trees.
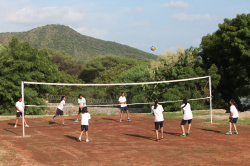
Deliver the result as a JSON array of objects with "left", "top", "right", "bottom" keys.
[{"left": 0, "top": 25, "right": 157, "bottom": 63}]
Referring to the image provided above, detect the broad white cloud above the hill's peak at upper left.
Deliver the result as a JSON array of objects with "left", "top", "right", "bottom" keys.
[{"left": 5, "top": 7, "right": 86, "bottom": 24}]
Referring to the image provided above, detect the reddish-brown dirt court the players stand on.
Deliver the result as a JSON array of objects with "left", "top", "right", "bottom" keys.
[{"left": 0, "top": 114, "right": 250, "bottom": 165}]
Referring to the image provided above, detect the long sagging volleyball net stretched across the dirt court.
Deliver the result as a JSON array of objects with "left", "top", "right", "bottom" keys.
[{"left": 21, "top": 76, "right": 212, "bottom": 136}]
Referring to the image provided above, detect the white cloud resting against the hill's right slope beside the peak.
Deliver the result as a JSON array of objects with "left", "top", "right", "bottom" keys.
[{"left": 71, "top": 27, "right": 109, "bottom": 40}]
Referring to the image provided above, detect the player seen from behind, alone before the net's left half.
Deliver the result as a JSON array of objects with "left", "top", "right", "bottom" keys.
[{"left": 78, "top": 107, "right": 91, "bottom": 142}]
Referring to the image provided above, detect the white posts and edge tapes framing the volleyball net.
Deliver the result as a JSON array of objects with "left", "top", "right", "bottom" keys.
[{"left": 21, "top": 76, "right": 212, "bottom": 137}]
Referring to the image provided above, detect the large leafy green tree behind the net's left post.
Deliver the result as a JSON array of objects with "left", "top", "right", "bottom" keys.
[{"left": 0, "top": 37, "right": 82, "bottom": 114}]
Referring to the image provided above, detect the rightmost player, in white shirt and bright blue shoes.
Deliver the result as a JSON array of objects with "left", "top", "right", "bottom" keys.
[{"left": 226, "top": 99, "right": 239, "bottom": 135}]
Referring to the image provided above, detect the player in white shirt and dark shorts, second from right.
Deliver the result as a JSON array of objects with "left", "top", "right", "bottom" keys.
[{"left": 180, "top": 99, "right": 193, "bottom": 137}]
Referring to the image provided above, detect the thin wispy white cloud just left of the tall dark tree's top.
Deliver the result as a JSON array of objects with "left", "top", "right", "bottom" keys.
[{"left": 171, "top": 13, "right": 216, "bottom": 21}]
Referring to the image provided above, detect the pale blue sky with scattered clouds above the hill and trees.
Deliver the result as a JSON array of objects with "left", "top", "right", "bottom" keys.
[{"left": 0, "top": 0, "right": 250, "bottom": 55}]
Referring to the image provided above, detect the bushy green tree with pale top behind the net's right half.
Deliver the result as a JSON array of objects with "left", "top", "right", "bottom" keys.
[{"left": 146, "top": 50, "right": 220, "bottom": 111}]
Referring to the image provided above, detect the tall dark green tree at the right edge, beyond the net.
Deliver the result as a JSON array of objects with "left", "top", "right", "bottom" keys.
[{"left": 200, "top": 14, "right": 250, "bottom": 109}]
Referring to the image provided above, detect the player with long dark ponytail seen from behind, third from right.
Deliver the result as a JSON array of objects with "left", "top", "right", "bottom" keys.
[{"left": 151, "top": 99, "right": 164, "bottom": 142}]
